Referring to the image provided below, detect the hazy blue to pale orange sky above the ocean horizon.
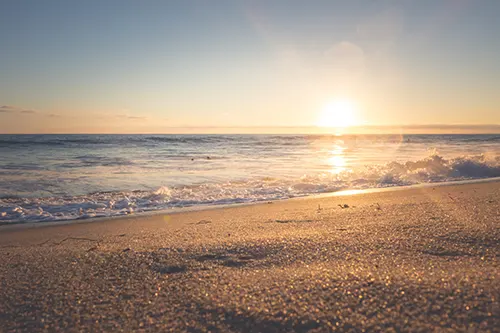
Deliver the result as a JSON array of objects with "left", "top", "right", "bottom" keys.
[{"left": 0, "top": 0, "right": 500, "bottom": 133}]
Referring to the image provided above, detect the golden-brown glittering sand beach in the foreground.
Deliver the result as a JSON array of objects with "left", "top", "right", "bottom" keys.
[{"left": 0, "top": 182, "right": 500, "bottom": 332}]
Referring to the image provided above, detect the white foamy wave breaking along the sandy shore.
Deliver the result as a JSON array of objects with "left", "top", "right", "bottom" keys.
[{"left": 0, "top": 154, "right": 500, "bottom": 224}]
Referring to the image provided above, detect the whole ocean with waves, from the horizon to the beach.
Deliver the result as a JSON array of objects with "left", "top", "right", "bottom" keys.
[{"left": 0, "top": 134, "right": 500, "bottom": 224}]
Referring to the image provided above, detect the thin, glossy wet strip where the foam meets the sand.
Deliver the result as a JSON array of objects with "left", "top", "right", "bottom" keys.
[{"left": 0, "top": 177, "right": 500, "bottom": 233}]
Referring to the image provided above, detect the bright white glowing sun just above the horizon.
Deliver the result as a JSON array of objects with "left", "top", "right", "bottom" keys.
[{"left": 317, "top": 99, "right": 356, "bottom": 128}]
